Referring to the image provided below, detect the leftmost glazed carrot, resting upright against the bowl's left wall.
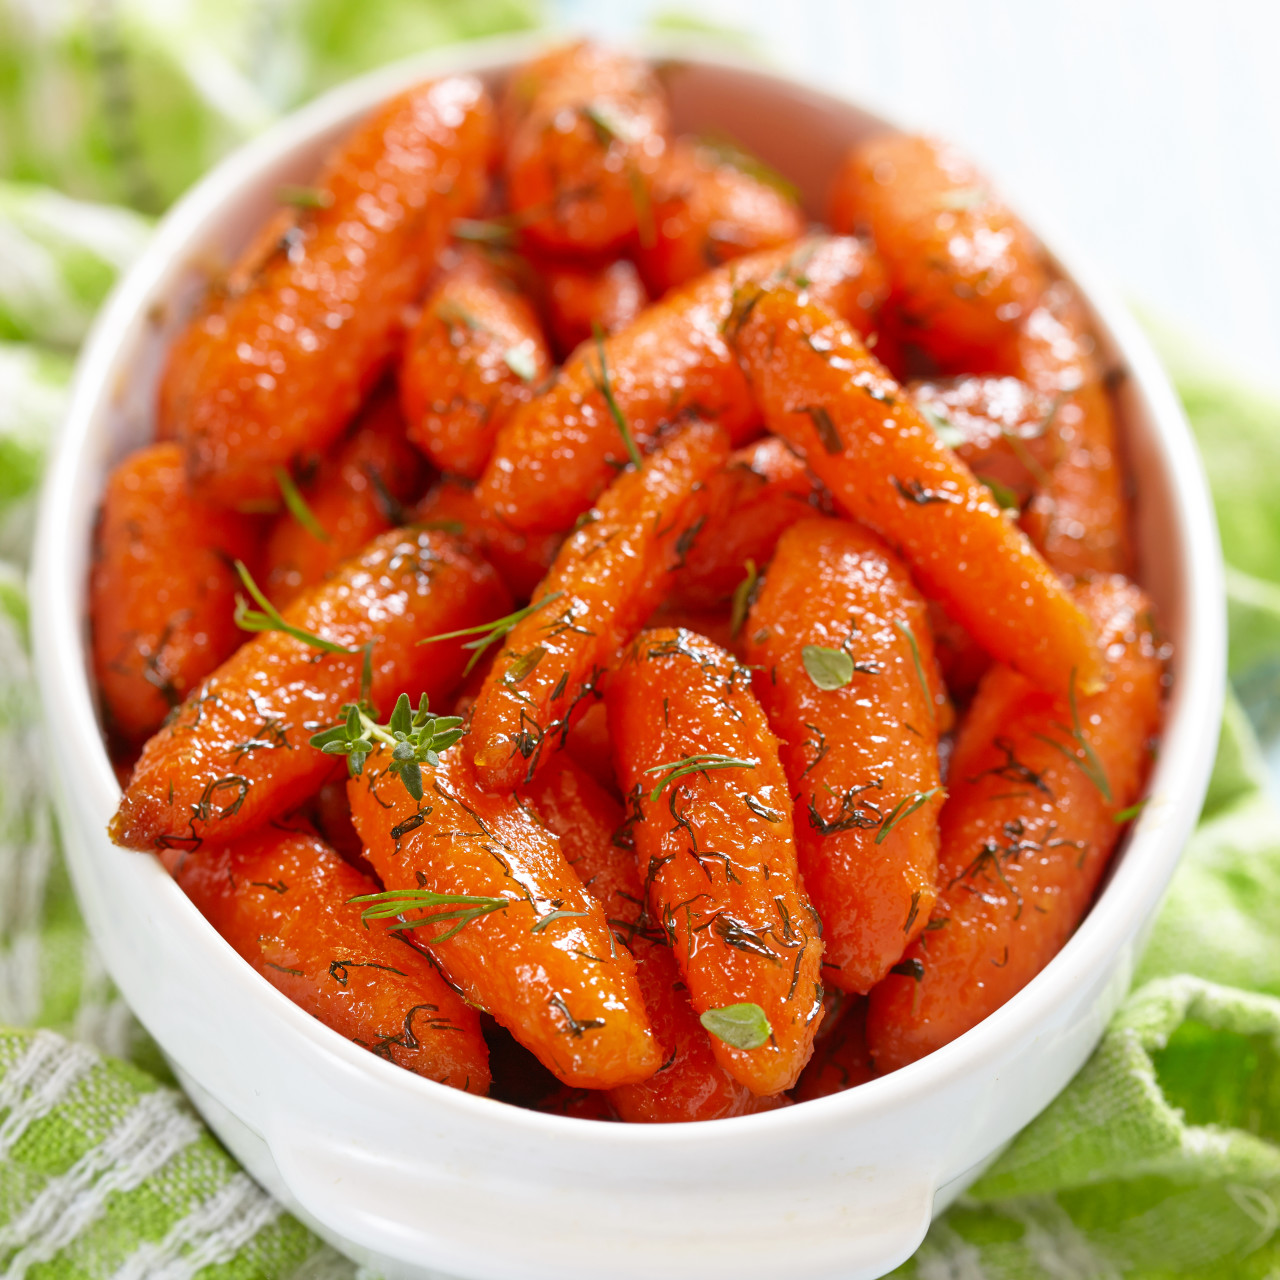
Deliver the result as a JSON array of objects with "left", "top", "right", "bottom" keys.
[{"left": 90, "top": 444, "right": 259, "bottom": 745}]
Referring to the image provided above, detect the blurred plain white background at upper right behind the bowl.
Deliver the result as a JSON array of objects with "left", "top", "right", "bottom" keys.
[{"left": 549, "top": 0, "right": 1280, "bottom": 389}]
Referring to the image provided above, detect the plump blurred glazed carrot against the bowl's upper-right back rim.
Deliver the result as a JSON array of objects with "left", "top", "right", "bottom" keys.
[{"left": 829, "top": 134, "right": 1048, "bottom": 372}]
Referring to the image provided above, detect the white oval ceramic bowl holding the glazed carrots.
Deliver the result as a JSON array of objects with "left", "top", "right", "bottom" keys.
[{"left": 33, "top": 30, "right": 1225, "bottom": 1280}]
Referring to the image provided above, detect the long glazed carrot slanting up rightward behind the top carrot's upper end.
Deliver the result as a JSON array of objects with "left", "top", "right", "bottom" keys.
[{"left": 479, "top": 236, "right": 882, "bottom": 530}]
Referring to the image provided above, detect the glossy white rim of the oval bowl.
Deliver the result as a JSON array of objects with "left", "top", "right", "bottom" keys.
[{"left": 32, "top": 31, "right": 1226, "bottom": 1149}]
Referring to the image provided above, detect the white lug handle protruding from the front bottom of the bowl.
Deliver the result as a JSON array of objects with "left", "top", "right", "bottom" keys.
[{"left": 270, "top": 1133, "right": 937, "bottom": 1280}]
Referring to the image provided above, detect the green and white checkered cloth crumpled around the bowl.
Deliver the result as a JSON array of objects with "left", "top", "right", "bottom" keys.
[{"left": 0, "top": 0, "right": 1280, "bottom": 1280}]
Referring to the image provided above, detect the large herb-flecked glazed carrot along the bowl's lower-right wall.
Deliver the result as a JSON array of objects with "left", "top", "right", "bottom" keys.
[{"left": 867, "top": 576, "right": 1162, "bottom": 1071}]
